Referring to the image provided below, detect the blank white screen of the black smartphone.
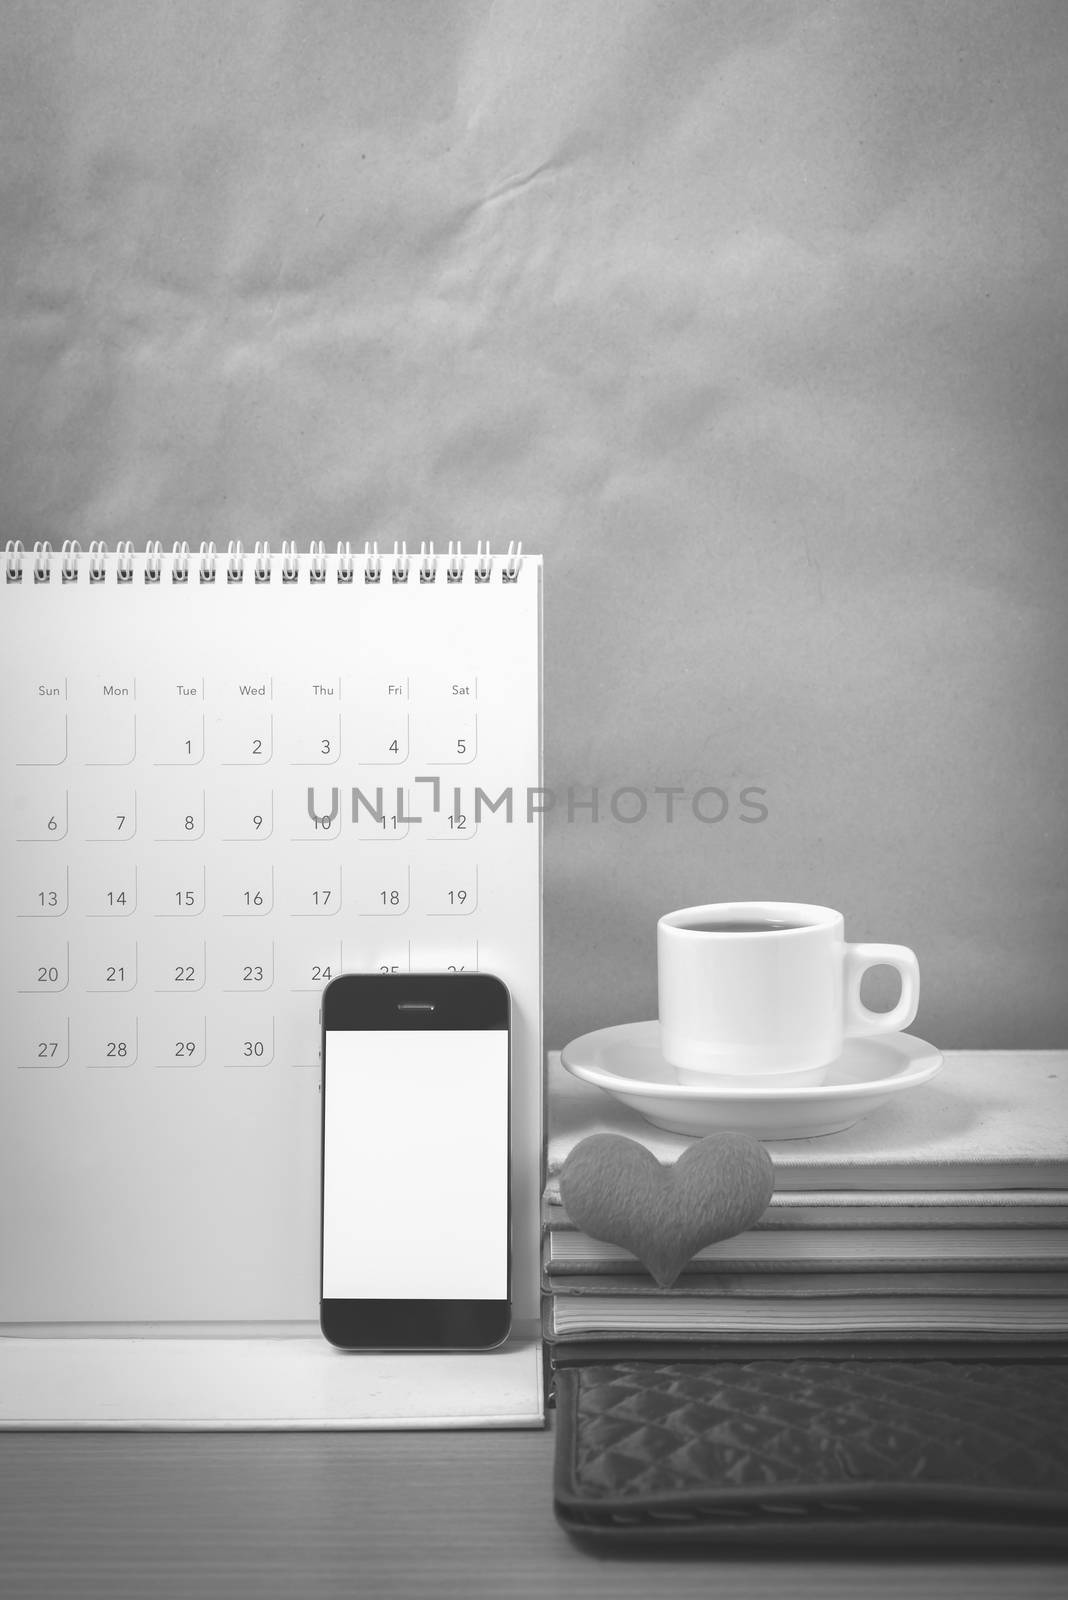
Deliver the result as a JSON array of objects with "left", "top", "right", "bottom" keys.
[{"left": 323, "top": 1029, "right": 508, "bottom": 1301}]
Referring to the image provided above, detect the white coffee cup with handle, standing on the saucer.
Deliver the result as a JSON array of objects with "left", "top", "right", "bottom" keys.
[{"left": 657, "top": 901, "right": 919, "bottom": 1090}]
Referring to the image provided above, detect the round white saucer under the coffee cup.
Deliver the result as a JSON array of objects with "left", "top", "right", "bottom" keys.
[{"left": 561, "top": 1022, "right": 942, "bottom": 1139}]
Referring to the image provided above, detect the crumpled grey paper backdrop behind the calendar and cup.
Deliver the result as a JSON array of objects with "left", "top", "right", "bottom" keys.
[{"left": 0, "top": 0, "right": 1068, "bottom": 1046}]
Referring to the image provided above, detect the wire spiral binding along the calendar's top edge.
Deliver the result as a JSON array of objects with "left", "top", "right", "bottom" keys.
[{"left": 3, "top": 539, "right": 523, "bottom": 584}]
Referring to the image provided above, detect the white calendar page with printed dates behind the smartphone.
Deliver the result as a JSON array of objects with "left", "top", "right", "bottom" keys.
[{"left": 0, "top": 554, "right": 542, "bottom": 1325}]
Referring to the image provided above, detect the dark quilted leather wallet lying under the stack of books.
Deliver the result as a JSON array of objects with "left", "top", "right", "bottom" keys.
[{"left": 555, "top": 1358, "right": 1068, "bottom": 1554}]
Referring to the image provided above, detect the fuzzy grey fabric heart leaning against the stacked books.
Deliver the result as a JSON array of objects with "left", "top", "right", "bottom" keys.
[{"left": 560, "top": 1133, "right": 775, "bottom": 1290}]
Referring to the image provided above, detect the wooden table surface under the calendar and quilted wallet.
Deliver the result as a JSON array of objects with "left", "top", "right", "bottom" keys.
[{"left": 0, "top": 1432, "right": 1068, "bottom": 1600}]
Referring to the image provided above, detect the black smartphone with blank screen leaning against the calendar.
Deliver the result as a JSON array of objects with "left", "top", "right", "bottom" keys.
[{"left": 320, "top": 973, "right": 512, "bottom": 1350}]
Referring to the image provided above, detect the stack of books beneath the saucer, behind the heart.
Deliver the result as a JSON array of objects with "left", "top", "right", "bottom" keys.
[{"left": 542, "top": 1051, "right": 1068, "bottom": 1365}]
